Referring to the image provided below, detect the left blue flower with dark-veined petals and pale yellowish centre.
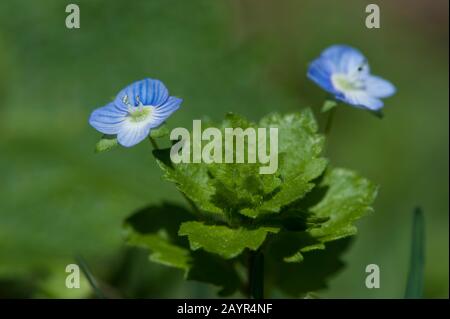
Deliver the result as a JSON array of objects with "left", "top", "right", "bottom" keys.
[{"left": 89, "top": 79, "right": 182, "bottom": 147}]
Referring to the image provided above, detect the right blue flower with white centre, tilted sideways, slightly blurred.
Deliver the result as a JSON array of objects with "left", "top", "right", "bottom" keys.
[{"left": 308, "top": 45, "right": 396, "bottom": 111}]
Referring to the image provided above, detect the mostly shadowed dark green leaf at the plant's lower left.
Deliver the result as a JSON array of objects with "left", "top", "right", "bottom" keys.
[{"left": 124, "top": 203, "right": 242, "bottom": 296}]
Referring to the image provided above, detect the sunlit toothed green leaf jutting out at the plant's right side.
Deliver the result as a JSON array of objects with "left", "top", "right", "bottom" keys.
[{"left": 278, "top": 168, "right": 377, "bottom": 262}]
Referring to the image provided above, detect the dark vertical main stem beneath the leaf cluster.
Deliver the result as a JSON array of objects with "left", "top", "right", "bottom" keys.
[{"left": 248, "top": 249, "right": 264, "bottom": 299}]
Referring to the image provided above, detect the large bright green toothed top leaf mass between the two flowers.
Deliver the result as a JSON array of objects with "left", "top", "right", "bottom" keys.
[{"left": 154, "top": 110, "right": 327, "bottom": 220}]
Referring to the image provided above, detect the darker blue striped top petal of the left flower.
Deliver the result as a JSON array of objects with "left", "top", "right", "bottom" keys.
[{"left": 115, "top": 79, "right": 169, "bottom": 108}]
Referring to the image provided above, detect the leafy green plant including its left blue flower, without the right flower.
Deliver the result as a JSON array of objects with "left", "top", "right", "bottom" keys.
[{"left": 90, "top": 79, "right": 377, "bottom": 298}]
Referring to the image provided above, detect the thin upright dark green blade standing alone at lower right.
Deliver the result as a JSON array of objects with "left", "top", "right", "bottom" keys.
[{"left": 405, "top": 207, "right": 425, "bottom": 299}]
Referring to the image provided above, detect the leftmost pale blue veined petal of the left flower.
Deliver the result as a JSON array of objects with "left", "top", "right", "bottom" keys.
[{"left": 89, "top": 103, "right": 127, "bottom": 134}]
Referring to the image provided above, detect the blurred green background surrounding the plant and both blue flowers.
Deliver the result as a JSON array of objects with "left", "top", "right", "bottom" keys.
[{"left": 0, "top": 0, "right": 449, "bottom": 298}]
